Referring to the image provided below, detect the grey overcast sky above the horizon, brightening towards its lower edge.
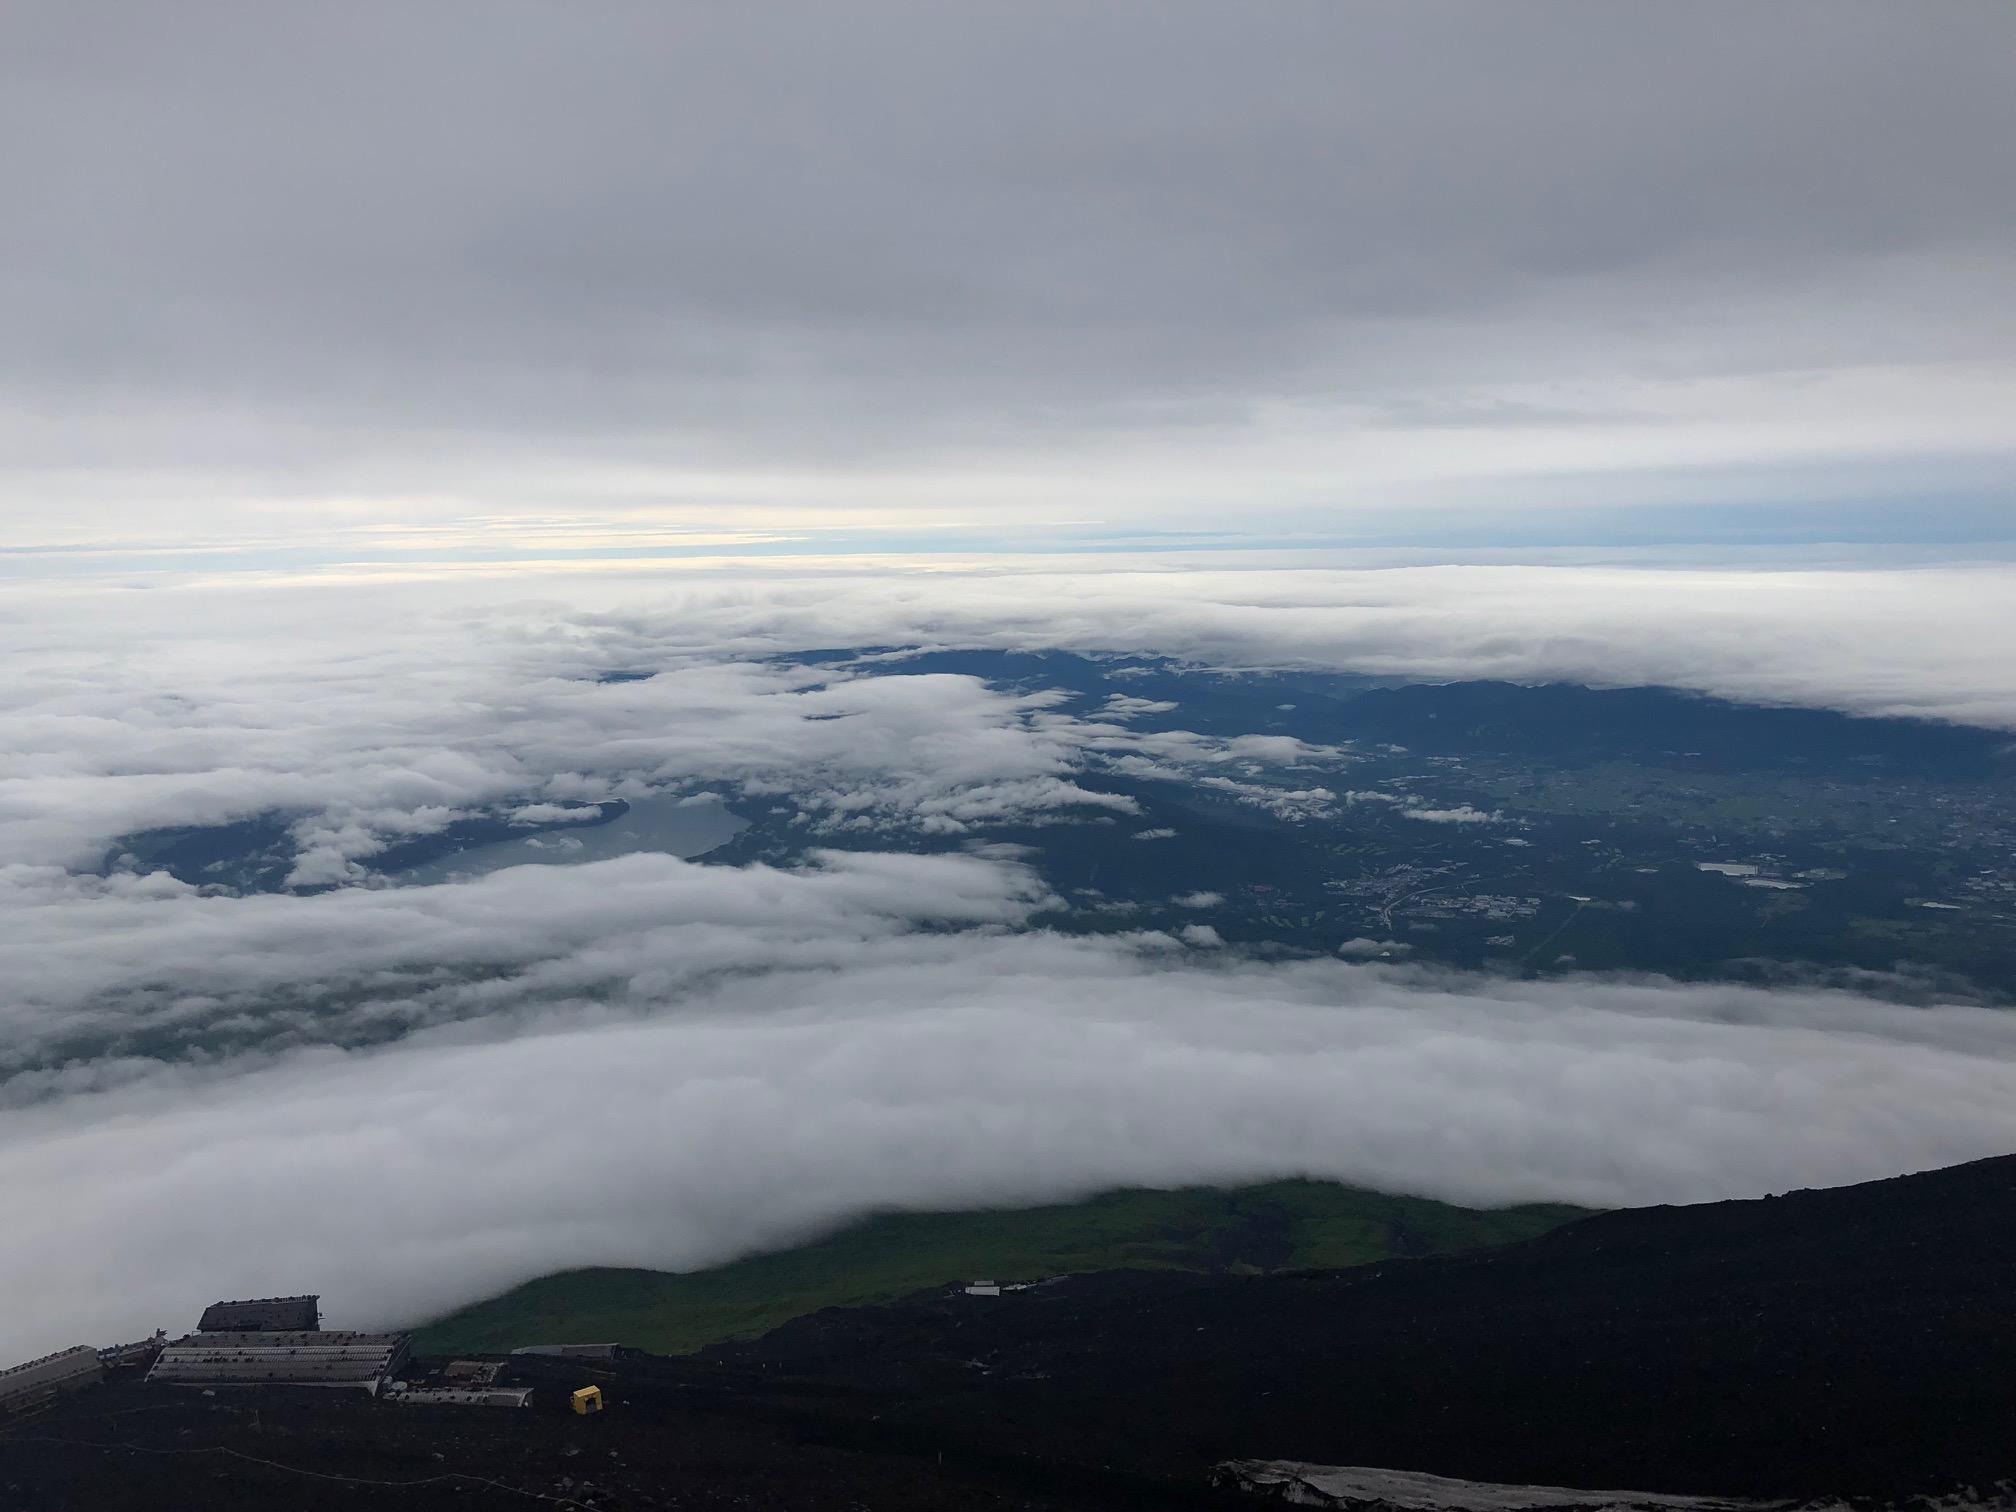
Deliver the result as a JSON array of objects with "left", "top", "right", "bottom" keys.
[{"left": 0, "top": 0, "right": 2016, "bottom": 548}]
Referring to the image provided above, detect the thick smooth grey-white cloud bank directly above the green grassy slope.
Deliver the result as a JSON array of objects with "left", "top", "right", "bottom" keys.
[{"left": 0, "top": 947, "right": 2016, "bottom": 1355}]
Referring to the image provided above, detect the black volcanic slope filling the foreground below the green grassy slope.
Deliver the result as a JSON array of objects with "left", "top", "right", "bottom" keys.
[{"left": 15, "top": 1157, "right": 2016, "bottom": 1512}]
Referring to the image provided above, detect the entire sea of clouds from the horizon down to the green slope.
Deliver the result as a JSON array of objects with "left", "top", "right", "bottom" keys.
[{"left": 0, "top": 566, "right": 2016, "bottom": 1353}]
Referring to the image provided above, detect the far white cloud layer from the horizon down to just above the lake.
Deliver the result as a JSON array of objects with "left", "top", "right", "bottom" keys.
[{"left": 0, "top": 562, "right": 2016, "bottom": 883}]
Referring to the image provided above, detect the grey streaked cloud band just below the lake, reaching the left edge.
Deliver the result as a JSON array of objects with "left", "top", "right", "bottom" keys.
[{"left": 0, "top": 853, "right": 1046, "bottom": 1107}]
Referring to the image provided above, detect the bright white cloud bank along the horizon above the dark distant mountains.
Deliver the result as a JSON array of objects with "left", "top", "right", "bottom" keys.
[{"left": 599, "top": 564, "right": 2016, "bottom": 730}]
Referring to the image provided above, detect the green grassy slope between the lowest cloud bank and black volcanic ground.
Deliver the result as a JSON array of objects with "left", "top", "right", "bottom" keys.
[{"left": 413, "top": 1181, "right": 1585, "bottom": 1355}]
